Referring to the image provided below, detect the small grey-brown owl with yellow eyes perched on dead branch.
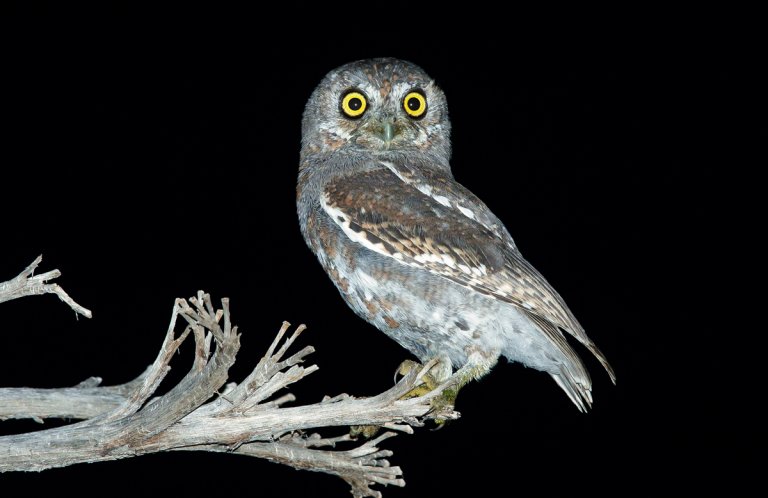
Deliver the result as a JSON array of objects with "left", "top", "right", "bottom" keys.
[{"left": 297, "top": 58, "right": 615, "bottom": 411}]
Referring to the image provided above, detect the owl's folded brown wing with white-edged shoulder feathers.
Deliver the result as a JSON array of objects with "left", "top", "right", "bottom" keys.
[{"left": 321, "top": 164, "right": 614, "bottom": 379}]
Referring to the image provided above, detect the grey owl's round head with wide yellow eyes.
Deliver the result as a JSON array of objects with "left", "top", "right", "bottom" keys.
[{"left": 302, "top": 58, "right": 450, "bottom": 163}]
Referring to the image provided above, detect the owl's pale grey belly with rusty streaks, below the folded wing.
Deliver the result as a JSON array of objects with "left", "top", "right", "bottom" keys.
[{"left": 332, "top": 249, "right": 548, "bottom": 370}]
